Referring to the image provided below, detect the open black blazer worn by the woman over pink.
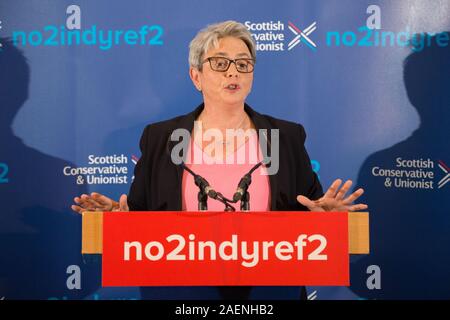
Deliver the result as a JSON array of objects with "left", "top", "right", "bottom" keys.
[{"left": 128, "top": 104, "right": 323, "bottom": 300}]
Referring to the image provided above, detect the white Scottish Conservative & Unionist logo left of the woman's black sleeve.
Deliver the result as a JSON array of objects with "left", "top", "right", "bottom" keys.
[{"left": 63, "top": 154, "right": 137, "bottom": 185}]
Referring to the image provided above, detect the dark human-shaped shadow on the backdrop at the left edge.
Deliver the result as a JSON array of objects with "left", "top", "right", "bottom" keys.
[{"left": 0, "top": 38, "right": 100, "bottom": 300}]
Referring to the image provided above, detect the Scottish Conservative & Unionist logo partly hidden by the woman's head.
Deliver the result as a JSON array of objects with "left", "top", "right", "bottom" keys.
[{"left": 244, "top": 21, "right": 317, "bottom": 51}]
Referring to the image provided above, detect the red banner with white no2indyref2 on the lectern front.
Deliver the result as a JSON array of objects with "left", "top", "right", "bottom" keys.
[{"left": 102, "top": 211, "right": 349, "bottom": 286}]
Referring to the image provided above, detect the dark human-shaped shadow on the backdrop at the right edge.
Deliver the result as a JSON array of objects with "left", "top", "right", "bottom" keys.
[{"left": 351, "top": 32, "right": 450, "bottom": 299}]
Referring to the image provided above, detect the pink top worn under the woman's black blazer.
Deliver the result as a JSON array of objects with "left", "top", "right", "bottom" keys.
[{"left": 182, "top": 131, "right": 270, "bottom": 211}]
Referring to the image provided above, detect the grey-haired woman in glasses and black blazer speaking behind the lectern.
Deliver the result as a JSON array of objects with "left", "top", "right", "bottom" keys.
[{"left": 72, "top": 21, "right": 367, "bottom": 299}]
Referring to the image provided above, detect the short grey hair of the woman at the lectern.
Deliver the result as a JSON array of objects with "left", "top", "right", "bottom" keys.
[{"left": 189, "top": 20, "right": 256, "bottom": 70}]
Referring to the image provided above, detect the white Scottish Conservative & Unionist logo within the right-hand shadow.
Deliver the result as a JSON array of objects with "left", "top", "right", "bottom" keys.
[{"left": 371, "top": 157, "right": 450, "bottom": 189}]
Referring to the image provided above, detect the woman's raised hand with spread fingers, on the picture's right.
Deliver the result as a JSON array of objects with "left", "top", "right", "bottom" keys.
[{"left": 297, "top": 179, "right": 368, "bottom": 212}]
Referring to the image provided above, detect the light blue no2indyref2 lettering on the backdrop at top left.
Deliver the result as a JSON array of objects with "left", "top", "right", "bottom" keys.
[{"left": 8, "top": 5, "right": 164, "bottom": 50}]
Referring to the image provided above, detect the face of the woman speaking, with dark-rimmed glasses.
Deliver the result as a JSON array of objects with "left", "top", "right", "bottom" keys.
[{"left": 190, "top": 37, "right": 253, "bottom": 106}]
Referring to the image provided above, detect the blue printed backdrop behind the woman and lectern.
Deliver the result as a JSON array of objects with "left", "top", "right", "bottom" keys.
[{"left": 0, "top": 0, "right": 450, "bottom": 299}]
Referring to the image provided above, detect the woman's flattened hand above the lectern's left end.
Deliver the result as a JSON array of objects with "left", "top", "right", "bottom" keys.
[{"left": 71, "top": 192, "right": 130, "bottom": 213}]
